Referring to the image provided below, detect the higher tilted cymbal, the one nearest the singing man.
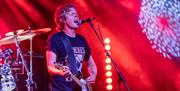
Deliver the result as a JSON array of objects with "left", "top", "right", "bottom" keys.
[{"left": 22, "top": 28, "right": 51, "bottom": 35}]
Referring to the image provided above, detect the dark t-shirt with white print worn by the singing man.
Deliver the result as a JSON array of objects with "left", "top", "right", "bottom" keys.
[{"left": 46, "top": 32, "right": 91, "bottom": 89}]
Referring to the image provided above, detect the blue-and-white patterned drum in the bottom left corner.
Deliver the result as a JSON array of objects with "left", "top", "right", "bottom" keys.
[{"left": 0, "top": 64, "right": 16, "bottom": 91}]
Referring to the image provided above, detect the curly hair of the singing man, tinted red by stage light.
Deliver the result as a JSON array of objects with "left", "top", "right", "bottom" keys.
[{"left": 54, "top": 4, "right": 76, "bottom": 30}]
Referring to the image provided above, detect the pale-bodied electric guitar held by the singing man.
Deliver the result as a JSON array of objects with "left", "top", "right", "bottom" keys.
[{"left": 54, "top": 63, "right": 93, "bottom": 91}]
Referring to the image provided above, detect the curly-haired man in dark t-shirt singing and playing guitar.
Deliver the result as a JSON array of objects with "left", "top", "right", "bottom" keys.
[{"left": 46, "top": 4, "right": 97, "bottom": 91}]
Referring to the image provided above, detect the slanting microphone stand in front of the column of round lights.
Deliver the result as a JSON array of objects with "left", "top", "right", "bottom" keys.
[{"left": 87, "top": 20, "right": 131, "bottom": 91}]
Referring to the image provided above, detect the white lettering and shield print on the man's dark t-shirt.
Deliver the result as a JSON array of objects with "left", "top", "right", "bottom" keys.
[{"left": 73, "top": 47, "right": 85, "bottom": 72}]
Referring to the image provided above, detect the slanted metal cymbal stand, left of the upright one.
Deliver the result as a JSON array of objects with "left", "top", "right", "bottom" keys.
[{"left": 14, "top": 35, "right": 33, "bottom": 91}]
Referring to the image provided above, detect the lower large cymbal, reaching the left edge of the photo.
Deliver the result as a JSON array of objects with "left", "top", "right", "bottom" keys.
[{"left": 0, "top": 34, "right": 35, "bottom": 45}]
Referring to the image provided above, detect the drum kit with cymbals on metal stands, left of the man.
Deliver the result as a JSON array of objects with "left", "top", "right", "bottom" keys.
[{"left": 0, "top": 28, "right": 51, "bottom": 91}]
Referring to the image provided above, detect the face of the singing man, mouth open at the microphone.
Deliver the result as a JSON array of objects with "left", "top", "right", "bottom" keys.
[{"left": 64, "top": 8, "right": 79, "bottom": 29}]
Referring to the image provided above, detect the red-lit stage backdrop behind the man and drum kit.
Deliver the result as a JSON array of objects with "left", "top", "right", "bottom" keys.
[{"left": 0, "top": 0, "right": 180, "bottom": 91}]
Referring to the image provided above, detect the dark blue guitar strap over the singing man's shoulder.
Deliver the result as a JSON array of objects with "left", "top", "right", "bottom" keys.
[{"left": 61, "top": 34, "right": 78, "bottom": 75}]
